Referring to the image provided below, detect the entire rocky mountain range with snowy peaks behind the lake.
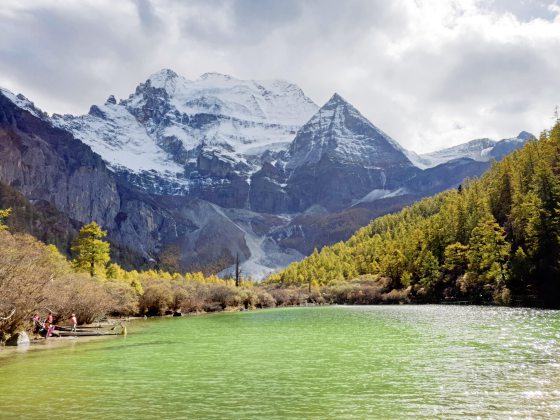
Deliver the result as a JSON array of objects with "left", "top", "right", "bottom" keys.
[{"left": 0, "top": 70, "right": 531, "bottom": 278}]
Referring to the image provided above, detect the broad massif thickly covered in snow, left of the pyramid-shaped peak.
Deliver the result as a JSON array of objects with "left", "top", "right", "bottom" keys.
[{"left": 53, "top": 69, "right": 318, "bottom": 194}]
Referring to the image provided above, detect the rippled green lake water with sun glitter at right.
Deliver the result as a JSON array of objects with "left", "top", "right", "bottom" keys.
[{"left": 0, "top": 305, "right": 560, "bottom": 419}]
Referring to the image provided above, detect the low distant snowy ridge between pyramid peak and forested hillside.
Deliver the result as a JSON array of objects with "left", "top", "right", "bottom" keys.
[{"left": 409, "top": 131, "right": 535, "bottom": 169}]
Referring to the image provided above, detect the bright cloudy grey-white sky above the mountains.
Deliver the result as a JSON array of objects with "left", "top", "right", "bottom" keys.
[{"left": 0, "top": 0, "right": 560, "bottom": 152}]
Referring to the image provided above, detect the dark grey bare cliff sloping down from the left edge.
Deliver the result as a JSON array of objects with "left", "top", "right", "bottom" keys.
[{"left": 0, "top": 95, "right": 195, "bottom": 260}]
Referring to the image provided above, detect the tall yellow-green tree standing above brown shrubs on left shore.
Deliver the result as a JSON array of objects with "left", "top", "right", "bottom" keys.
[{"left": 72, "top": 222, "right": 111, "bottom": 277}]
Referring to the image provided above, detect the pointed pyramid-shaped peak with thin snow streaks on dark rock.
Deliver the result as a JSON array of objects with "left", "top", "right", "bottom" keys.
[{"left": 285, "top": 94, "right": 419, "bottom": 211}]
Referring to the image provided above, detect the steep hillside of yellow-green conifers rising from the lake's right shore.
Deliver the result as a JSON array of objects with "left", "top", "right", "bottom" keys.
[{"left": 267, "top": 120, "right": 560, "bottom": 307}]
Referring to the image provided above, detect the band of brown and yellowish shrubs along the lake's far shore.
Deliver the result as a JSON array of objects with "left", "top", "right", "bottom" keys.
[{"left": 0, "top": 212, "right": 408, "bottom": 338}]
